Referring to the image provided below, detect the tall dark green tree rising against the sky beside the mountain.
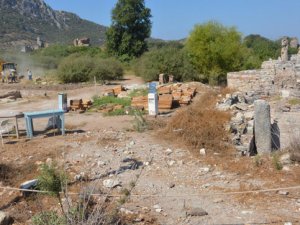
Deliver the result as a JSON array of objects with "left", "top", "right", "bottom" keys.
[{"left": 106, "top": 0, "right": 152, "bottom": 59}]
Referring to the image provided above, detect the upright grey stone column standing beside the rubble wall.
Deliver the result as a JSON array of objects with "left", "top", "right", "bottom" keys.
[{"left": 254, "top": 100, "right": 272, "bottom": 154}]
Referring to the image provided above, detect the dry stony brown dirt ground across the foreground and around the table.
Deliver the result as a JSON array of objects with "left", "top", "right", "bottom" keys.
[{"left": 0, "top": 76, "right": 300, "bottom": 225}]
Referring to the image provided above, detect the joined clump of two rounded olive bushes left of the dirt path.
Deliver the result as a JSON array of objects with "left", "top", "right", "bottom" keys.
[{"left": 57, "top": 54, "right": 124, "bottom": 83}]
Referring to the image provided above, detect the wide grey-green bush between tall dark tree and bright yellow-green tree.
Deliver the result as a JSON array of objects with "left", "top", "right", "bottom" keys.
[{"left": 134, "top": 47, "right": 200, "bottom": 81}]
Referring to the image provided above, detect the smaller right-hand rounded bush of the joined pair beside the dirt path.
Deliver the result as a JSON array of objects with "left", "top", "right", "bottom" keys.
[{"left": 90, "top": 58, "right": 124, "bottom": 82}]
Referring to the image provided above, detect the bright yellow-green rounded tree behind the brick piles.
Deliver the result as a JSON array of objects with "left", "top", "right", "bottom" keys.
[{"left": 186, "top": 21, "right": 245, "bottom": 84}]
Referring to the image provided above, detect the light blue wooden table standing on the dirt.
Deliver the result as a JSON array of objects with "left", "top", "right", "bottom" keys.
[{"left": 24, "top": 109, "right": 65, "bottom": 138}]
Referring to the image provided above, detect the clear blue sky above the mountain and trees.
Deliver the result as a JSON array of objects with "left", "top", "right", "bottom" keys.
[{"left": 44, "top": 0, "right": 300, "bottom": 40}]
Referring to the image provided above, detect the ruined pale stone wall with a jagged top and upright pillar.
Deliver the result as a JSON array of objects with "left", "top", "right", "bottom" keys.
[{"left": 227, "top": 38, "right": 300, "bottom": 97}]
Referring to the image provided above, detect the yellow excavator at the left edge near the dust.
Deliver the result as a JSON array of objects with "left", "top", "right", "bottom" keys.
[{"left": 0, "top": 59, "right": 18, "bottom": 83}]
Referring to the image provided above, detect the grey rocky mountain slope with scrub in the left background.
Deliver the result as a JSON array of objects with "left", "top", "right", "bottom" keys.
[{"left": 0, "top": 0, "right": 106, "bottom": 49}]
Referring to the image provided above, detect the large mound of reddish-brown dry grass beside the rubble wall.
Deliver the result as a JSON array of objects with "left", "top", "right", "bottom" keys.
[{"left": 164, "top": 91, "right": 230, "bottom": 153}]
